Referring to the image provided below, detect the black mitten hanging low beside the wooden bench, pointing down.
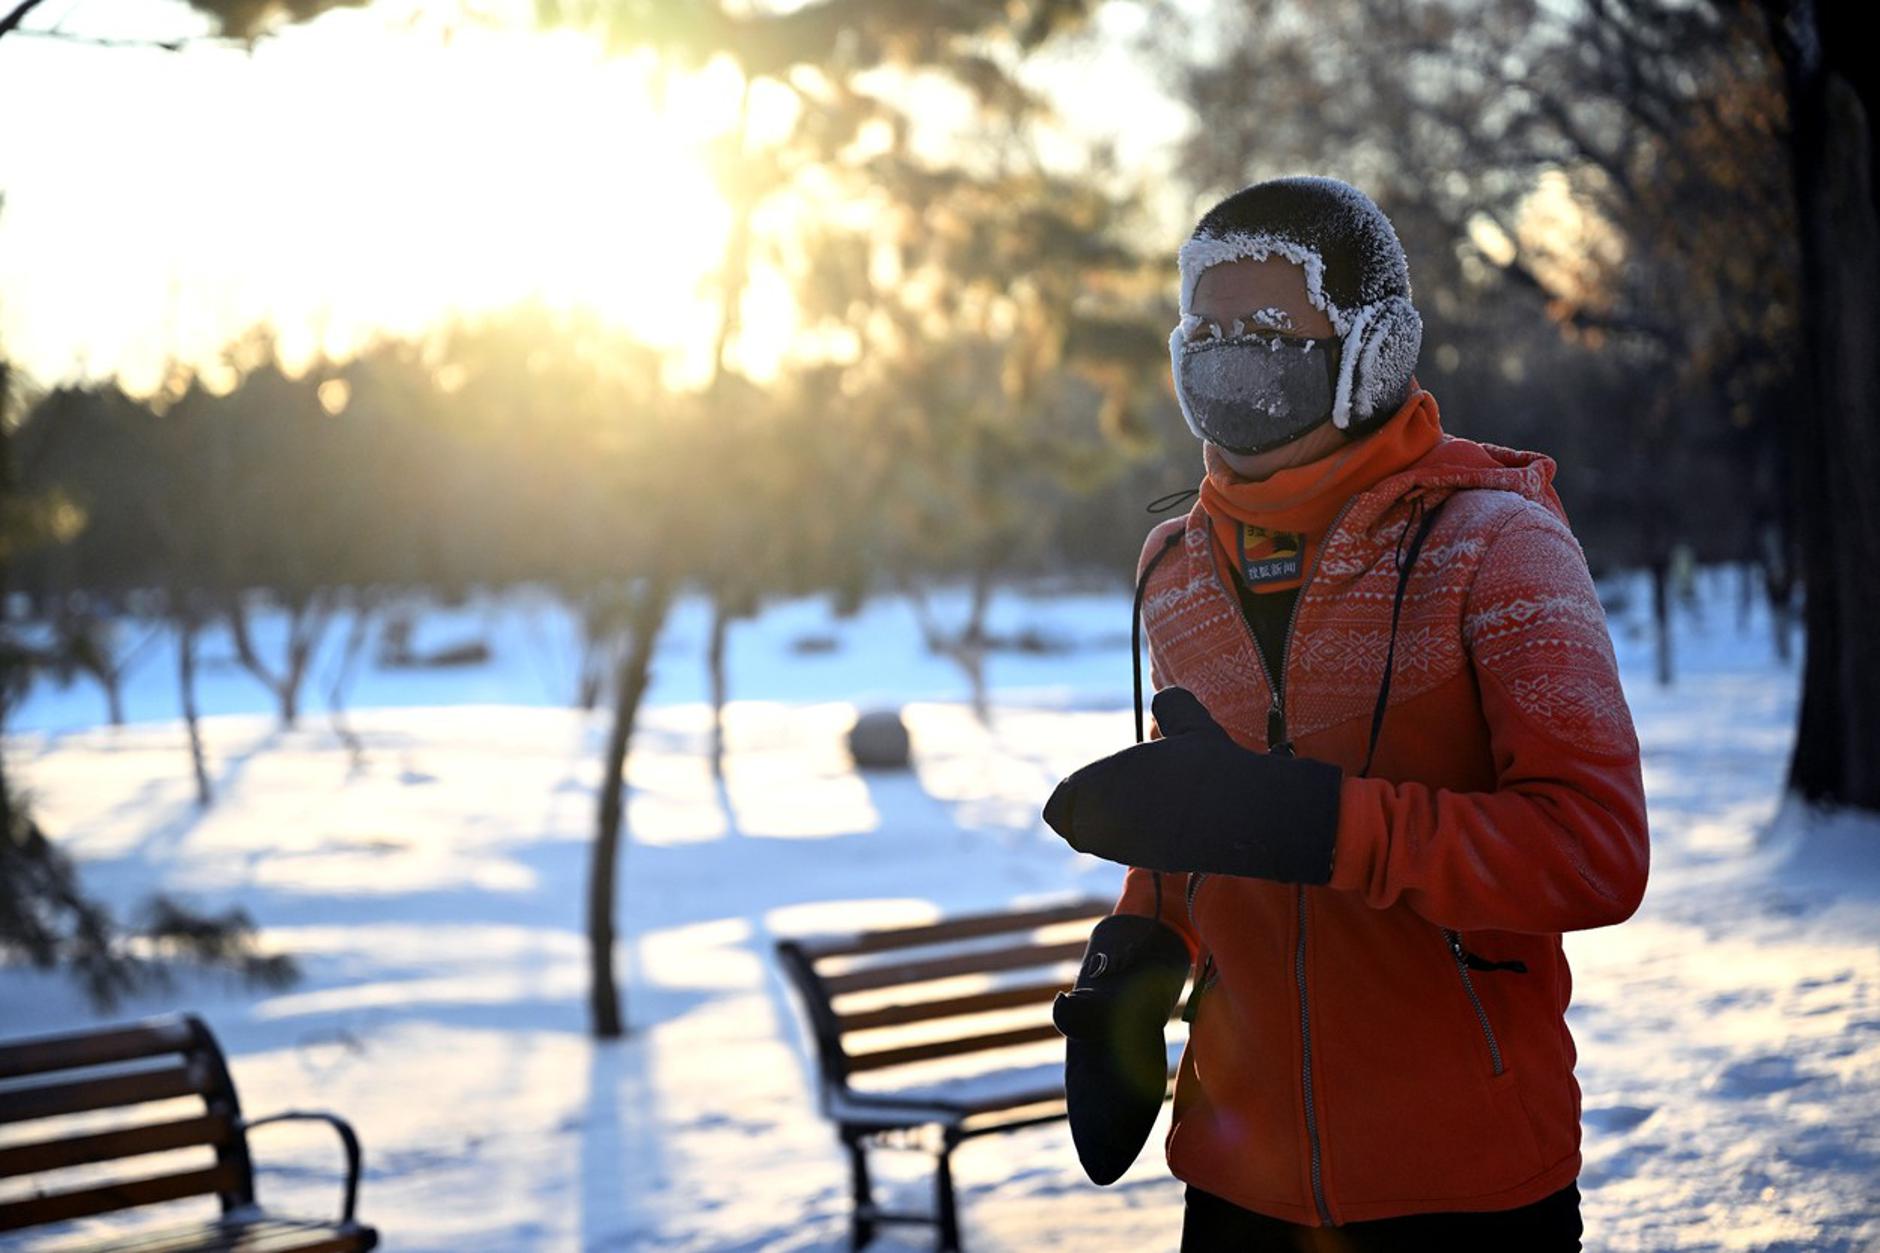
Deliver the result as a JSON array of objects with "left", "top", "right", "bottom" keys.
[{"left": 1051, "top": 914, "right": 1190, "bottom": 1183}]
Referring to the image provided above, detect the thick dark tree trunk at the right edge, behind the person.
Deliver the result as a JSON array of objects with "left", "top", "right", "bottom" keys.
[{"left": 1763, "top": 0, "right": 1880, "bottom": 811}]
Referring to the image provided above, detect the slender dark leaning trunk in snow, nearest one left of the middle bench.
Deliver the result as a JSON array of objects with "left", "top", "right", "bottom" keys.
[{"left": 587, "top": 574, "right": 671, "bottom": 1040}]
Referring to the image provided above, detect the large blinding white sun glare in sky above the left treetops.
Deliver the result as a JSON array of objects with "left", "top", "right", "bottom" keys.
[{"left": 0, "top": 13, "right": 795, "bottom": 391}]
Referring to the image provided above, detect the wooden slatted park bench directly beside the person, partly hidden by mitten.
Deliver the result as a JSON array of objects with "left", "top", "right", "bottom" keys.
[{"left": 776, "top": 899, "right": 1181, "bottom": 1249}]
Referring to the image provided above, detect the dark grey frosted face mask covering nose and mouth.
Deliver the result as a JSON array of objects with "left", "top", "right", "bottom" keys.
[{"left": 1169, "top": 314, "right": 1340, "bottom": 455}]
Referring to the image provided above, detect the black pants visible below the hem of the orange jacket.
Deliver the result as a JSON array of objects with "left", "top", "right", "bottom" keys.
[{"left": 1181, "top": 1183, "right": 1581, "bottom": 1253}]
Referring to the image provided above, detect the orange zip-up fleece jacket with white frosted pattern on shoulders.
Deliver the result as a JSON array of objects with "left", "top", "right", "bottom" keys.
[{"left": 1117, "top": 400, "right": 1649, "bottom": 1225}]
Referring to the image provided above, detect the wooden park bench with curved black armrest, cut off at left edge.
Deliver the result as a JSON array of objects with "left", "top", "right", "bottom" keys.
[{"left": 0, "top": 1016, "right": 378, "bottom": 1253}]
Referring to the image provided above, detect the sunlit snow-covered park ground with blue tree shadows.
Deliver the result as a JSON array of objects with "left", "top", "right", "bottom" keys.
[{"left": 0, "top": 572, "right": 1880, "bottom": 1251}]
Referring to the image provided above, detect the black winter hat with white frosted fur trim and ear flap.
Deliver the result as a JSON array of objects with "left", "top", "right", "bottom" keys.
[{"left": 1177, "top": 175, "right": 1423, "bottom": 433}]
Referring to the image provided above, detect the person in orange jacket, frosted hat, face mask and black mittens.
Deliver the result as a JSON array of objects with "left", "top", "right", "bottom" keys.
[{"left": 1045, "top": 177, "right": 1651, "bottom": 1253}]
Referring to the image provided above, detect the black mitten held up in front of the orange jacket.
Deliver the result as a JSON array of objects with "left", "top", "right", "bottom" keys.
[{"left": 1045, "top": 687, "right": 1344, "bottom": 884}]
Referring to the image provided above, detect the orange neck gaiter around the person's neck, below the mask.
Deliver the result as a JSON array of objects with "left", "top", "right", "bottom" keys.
[{"left": 1201, "top": 384, "right": 1442, "bottom": 593}]
